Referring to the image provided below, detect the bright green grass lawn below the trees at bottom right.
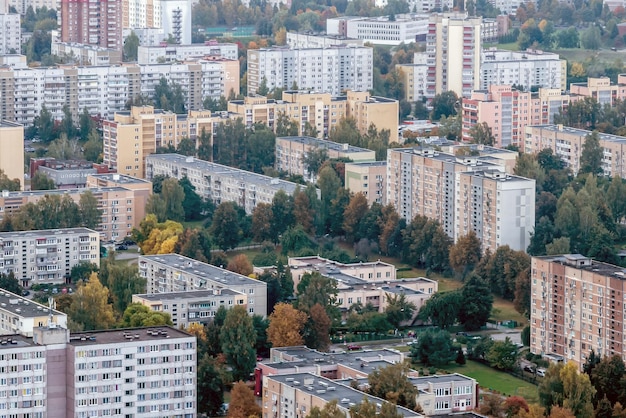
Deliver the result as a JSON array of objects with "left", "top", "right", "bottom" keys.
[{"left": 443, "top": 360, "right": 539, "bottom": 403}]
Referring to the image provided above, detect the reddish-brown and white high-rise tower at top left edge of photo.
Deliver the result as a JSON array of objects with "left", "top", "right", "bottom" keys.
[{"left": 59, "top": 0, "right": 123, "bottom": 50}]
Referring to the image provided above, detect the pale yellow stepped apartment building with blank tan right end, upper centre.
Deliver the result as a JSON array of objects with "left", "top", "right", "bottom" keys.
[{"left": 228, "top": 90, "right": 398, "bottom": 142}]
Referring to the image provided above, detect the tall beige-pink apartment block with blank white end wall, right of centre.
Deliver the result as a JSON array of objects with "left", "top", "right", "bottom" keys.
[{"left": 387, "top": 148, "right": 535, "bottom": 251}]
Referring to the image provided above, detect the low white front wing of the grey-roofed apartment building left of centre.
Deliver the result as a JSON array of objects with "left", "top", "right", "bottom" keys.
[{"left": 132, "top": 288, "right": 248, "bottom": 328}]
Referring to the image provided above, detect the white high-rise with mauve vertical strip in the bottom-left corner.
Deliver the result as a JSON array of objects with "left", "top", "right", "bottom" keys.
[{"left": 0, "top": 323, "right": 197, "bottom": 418}]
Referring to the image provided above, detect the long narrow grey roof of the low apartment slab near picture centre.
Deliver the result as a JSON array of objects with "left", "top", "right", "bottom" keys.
[{"left": 146, "top": 154, "right": 299, "bottom": 194}]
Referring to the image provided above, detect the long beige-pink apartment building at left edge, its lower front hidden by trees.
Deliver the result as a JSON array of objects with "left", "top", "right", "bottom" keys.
[{"left": 0, "top": 187, "right": 145, "bottom": 241}]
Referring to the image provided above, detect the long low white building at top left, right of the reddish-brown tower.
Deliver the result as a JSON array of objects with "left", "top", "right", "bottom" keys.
[{"left": 137, "top": 41, "right": 239, "bottom": 65}]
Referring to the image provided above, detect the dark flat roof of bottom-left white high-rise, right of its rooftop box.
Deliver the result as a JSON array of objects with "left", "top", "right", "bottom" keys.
[{"left": 70, "top": 326, "right": 195, "bottom": 346}]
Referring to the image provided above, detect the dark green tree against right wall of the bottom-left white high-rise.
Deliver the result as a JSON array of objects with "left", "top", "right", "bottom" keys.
[{"left": 198, "top": 354, "right": 226, "bottom": 416}]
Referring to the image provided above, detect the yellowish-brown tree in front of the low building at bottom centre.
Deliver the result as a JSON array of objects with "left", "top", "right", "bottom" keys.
[{"left": 367, "top": 363, "right": 417, "bottom": 409}]
